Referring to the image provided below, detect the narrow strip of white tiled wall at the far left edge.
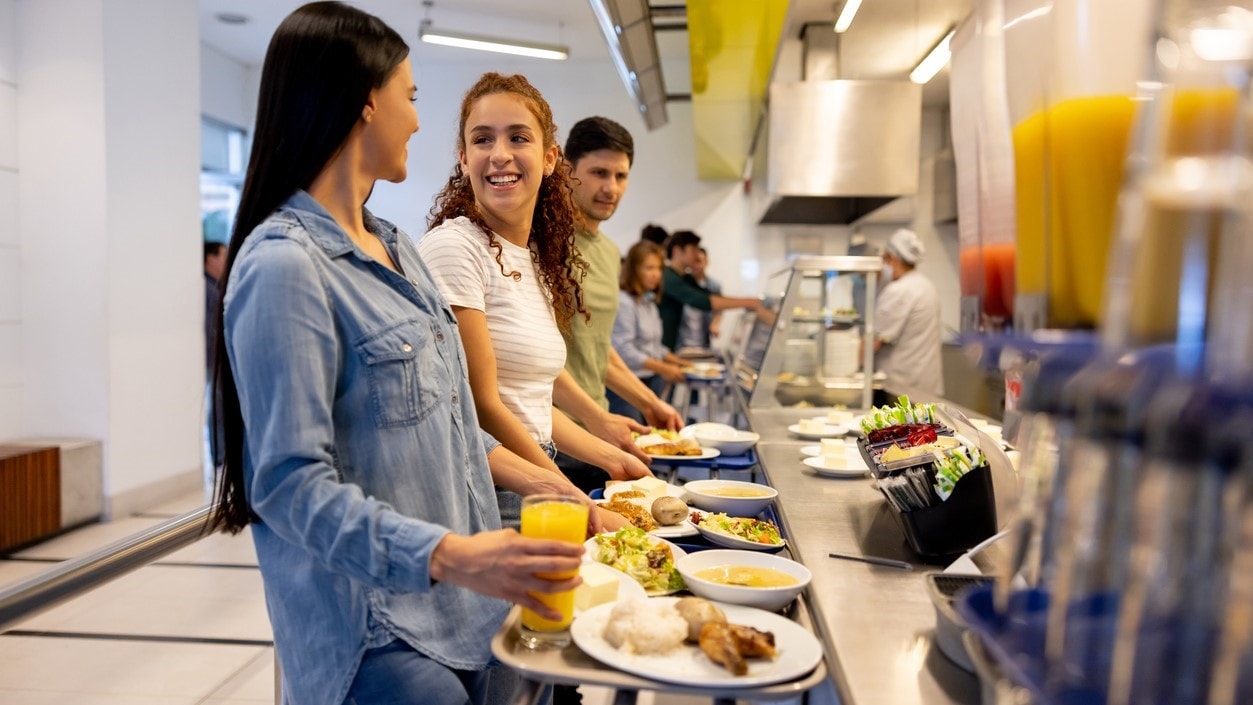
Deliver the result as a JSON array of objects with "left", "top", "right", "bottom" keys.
[{"left": 0, "top": 0, "right": 23, "bottom": 438}]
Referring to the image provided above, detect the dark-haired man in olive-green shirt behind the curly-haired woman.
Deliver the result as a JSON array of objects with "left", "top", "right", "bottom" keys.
[{"left": 554, "top": 116, "right": 683, "bottom": 491}]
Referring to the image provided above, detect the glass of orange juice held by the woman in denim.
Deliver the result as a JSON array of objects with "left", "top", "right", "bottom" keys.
[{"left": 523, "top": 495, "right": 588, "bottom": 649}]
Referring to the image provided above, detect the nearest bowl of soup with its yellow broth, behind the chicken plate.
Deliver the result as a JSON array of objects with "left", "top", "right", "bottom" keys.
[{"left": 674, "top": 550, "right": 813, "bottom": 612}]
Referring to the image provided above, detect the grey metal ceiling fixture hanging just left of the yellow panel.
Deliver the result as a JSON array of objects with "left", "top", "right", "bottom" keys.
[{"left": 588, "top": 0, "right": 669, "bottom": 130}]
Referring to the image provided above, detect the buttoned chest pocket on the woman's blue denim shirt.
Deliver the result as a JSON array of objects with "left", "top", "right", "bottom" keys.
[{"left": 353, "top": 319, "right": 447, "bottom": 428}]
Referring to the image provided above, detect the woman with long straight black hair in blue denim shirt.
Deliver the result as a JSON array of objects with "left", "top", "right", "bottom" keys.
[{"left": 209, "top": 3, "right": 584, "bottom": 705}]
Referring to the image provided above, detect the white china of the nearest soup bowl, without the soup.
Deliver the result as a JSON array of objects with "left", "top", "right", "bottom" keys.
[{"left": 674, "top": 550, "right": 813, "bottom": 612}]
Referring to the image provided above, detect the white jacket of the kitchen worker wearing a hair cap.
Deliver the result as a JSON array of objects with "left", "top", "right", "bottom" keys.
[{"left": 875, "top": 269, "right": 944, "bottom": 396}]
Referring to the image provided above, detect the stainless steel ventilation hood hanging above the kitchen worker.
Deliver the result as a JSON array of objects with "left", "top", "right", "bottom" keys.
[{"left": 761, "top": 80, "right": 922, "bottom": 224}]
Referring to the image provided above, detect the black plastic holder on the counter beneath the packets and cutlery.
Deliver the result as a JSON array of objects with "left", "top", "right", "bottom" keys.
[{"left": 883, "top": 465, "right": 996, "bottom": 563}]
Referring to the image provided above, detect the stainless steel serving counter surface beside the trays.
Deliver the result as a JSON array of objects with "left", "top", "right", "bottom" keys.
[{"left": 748, "top": 408, "right": 980, "bottom": 705}]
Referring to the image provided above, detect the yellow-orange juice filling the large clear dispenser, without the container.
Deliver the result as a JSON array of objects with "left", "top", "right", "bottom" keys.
[{"left": 1014, "top": 95, "right": 1135, "bottom": 328}]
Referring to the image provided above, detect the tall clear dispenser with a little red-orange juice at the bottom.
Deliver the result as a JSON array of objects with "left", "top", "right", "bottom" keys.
[{"left": 949, "top": 0, "right": 1015, "bottom": 332}]
